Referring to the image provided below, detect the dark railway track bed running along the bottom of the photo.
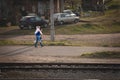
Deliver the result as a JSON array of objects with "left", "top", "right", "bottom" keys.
[{"left": 0, "top": 63, "right": 120, "bottom": 80}]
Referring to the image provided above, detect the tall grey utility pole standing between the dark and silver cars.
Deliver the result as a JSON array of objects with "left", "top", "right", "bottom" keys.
[{"left": 50, "top": 0, "right": 55, "bottom": 41}]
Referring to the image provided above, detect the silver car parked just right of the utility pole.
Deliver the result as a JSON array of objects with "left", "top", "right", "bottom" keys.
[{"left": 54, "top": 13, "right": 80, "bottom": 24}]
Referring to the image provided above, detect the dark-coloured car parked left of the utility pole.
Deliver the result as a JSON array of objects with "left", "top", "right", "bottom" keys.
[{"left": 19, "top": 16, "right": 48, "bottom": 29}]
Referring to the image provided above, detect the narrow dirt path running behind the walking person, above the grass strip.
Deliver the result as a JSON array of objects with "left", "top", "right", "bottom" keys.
[{"left": 0, "top": 33, "right": 120, "bottom": 42}]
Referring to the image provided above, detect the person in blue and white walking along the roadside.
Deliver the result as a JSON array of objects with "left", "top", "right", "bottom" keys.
[{"left": 34, "top": 26, "right": 43, "bottom": 47}]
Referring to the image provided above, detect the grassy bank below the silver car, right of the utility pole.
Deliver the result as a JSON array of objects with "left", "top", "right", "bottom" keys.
[{"left": 56, "top": 23, "right": 120, "bottom": 35}]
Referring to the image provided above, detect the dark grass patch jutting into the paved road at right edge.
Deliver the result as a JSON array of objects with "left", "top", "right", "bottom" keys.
[{"left": 80, "top": 51, "right": 120, "bottom": 58}]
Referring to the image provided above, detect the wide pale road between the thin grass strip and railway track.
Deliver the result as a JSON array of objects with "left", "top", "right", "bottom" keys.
[{"left": 0, "top": 46, "right": 120, "bottom": 63}]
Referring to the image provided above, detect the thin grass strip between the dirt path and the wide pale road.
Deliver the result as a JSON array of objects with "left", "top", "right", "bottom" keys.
[{"left": 0, "top": 39, "right": 120, "bottom": 47}]
